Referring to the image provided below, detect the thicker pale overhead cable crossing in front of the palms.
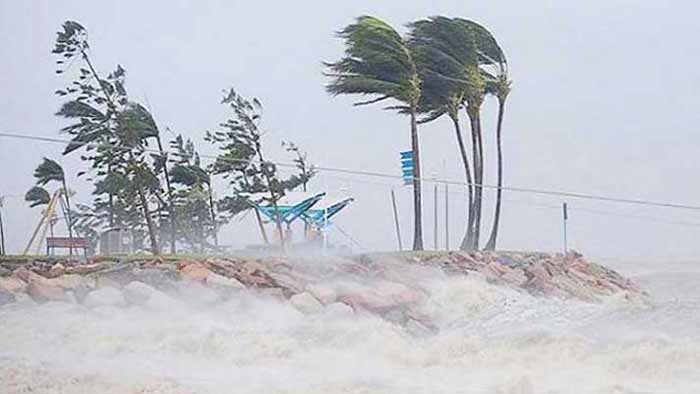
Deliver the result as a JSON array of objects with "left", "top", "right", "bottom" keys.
[{"left": 0, "top": 132, "right": 700, "bottom": 211}]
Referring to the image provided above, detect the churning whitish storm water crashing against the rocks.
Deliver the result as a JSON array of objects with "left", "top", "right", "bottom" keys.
[{"left": 0, "top": 262, "right": 700, "bottom": 394}]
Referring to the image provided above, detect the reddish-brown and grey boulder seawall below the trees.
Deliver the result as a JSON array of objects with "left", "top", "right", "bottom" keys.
[{"left": 0, "top": 252, "right": 646, "bottom": 329}]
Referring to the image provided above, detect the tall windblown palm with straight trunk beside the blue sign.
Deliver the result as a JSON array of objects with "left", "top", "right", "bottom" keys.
[{"left": 325, "top": 16, "right": 423, "bottom": 250}]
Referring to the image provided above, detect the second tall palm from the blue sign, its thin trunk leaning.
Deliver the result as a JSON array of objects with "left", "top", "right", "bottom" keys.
[{"left": 409, "top": 16, "right": 476, "bottom": 249}]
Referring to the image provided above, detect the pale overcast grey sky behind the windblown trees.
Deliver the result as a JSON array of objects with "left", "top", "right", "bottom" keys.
[{"left": 0, "top": 0, "right": 700, "bottom": 257}]
